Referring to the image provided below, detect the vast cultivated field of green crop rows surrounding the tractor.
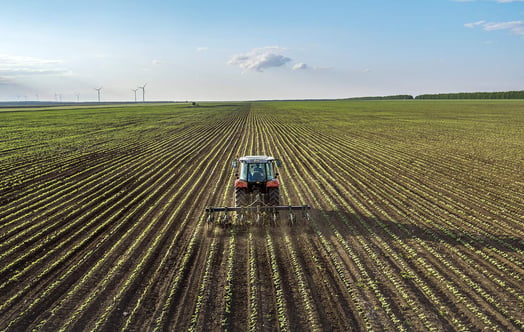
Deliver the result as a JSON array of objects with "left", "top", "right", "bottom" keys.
[{"left": 0, "top": 101, "right": 524, "bottom": 331}]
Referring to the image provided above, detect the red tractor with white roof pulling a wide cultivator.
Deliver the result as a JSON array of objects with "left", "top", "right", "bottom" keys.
[{"left": 205, "top": 156, "right": 310, "bottom": 225}]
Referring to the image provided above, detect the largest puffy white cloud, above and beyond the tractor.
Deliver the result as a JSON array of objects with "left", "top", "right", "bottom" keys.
[{"left": 228, "top": 46, "right": 291, "bottom": 72}]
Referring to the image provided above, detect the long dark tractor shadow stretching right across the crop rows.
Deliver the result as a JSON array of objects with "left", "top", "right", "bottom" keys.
[{"left": 320, "top": 209, "right": 524, "bottom": 252}]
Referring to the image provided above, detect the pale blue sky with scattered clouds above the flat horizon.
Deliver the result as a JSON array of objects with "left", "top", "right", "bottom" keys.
[{"left": 0, "top": 0, "right": 524, "bottom": 102}]
